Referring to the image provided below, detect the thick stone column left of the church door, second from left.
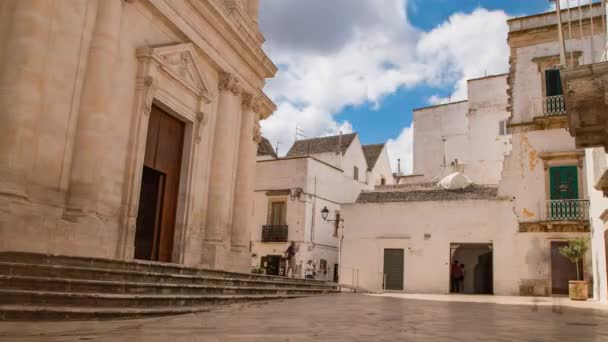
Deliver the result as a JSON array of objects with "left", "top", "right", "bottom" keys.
[{"left": 67, "top": 0, "right": 122, "bottom": 214}]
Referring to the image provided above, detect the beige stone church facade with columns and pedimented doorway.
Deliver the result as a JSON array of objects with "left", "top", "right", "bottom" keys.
[{"left": 0, "top": 0, "right": 277, "bottom": 271}]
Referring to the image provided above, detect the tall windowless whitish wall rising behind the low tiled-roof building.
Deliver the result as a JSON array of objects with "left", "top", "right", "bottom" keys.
[{"left": 414, "top": 75, "right": 510, "bottom": 184}]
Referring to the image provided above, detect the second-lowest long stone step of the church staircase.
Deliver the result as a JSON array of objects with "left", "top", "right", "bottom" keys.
[{"left": 0, "top": 289, "right": 310, "bottom": 308}]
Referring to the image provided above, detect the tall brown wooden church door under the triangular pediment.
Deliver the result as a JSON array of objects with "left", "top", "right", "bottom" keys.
[{"left": 135, "top": 106, "right": 185, "bottom": 262}]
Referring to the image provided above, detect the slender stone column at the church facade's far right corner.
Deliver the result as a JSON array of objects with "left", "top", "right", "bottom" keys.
[{"left": 230, "top": 94, "right": 260, "bottom": 272}]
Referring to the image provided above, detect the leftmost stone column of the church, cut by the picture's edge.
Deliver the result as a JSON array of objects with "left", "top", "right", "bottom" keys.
[{"left": 0, "top": 0, "right": 52, "bottom": 198}]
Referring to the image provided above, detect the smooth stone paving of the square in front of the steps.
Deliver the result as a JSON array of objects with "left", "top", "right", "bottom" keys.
[{"left": 0, "top": 294, "right": 608, "bottom": 342}]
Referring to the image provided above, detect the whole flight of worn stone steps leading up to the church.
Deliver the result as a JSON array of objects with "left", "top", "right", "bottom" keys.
[{"left": 0, "top": 252, "right": 337, "bottom": 320}]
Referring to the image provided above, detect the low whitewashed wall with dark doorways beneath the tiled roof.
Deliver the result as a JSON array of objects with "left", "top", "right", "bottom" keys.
[{"left": 342, "top": 200, "right": 590, "bottom": 296}]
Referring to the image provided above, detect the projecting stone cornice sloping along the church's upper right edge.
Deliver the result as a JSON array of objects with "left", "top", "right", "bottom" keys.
[{"left": 187, "top": 0, "right": 278, "bottom": 78}]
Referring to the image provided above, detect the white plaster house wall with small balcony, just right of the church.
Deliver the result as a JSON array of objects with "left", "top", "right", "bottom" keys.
[{"left": 249, "top": 156, "right": 372, "bottom": 278}]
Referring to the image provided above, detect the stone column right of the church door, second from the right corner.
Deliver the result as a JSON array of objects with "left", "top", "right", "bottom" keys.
[{"left": 203, "top": 73, "right": 241, "bottom": 269}]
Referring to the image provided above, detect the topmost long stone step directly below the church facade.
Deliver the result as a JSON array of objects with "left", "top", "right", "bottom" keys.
[{"left": 0, "top": 251, "right": 324, "bottom": 284}]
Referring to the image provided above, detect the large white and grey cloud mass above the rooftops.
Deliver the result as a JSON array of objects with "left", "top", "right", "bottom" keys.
[{"left": 261, "top": 0, "right": 508, "bottom": 170}]
